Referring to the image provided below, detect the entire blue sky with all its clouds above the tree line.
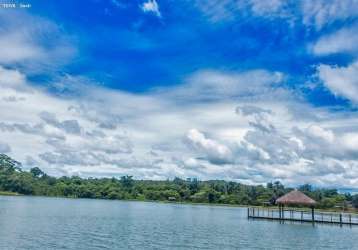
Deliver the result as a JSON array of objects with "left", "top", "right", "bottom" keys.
[{"left": 0, "top": 0, "right": 358, "bottom": 189}]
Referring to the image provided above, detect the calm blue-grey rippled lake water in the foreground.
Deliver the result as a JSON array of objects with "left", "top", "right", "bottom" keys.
[{"left": 0, "top": 196, "right": 358, "bottom": 250}]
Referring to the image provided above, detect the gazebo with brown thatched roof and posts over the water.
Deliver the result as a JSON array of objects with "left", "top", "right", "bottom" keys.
[{"left": 276, "top": 190, "right": 316, "bottom": 223}]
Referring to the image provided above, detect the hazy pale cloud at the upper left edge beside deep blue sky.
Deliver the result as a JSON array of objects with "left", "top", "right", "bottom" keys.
[{"left": 0, "top": 10, "right": 76, "bottom": 72}]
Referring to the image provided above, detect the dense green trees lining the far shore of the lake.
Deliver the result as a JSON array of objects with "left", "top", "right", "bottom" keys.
[{"left": 0, "top": 154, "right": 358, "bottom": 208}]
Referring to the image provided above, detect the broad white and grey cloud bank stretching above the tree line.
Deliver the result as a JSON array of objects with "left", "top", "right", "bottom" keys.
[{"left": 0, "top": 63, "right": 358, "bottom": 186}]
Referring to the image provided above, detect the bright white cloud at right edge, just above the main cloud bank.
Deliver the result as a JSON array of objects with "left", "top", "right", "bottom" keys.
[{"left": 317, "top": 61, "right": 358, "bottom": 103}]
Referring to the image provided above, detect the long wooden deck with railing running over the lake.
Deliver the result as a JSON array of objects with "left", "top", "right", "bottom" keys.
[{"left": 247, "top": 207, "right": 358, "bottom": 226}]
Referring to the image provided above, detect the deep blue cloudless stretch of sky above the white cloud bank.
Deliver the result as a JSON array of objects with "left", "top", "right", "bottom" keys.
[{"left": 18, "top": 1, "right": 355, "bottom": 94}]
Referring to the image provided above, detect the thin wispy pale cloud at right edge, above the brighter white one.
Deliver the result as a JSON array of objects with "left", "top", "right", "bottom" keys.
[{"left": 312, "top": 25, "right": 358, "bottom": 55}]
